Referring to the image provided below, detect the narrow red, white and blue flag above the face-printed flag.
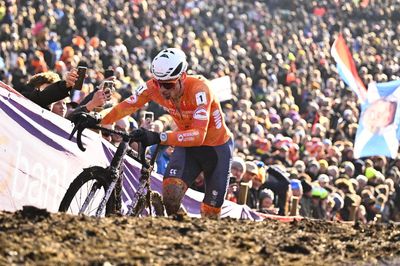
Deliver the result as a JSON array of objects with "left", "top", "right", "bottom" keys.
[{"left": 331, "top": 34, "right": 367, "bottom": 103}]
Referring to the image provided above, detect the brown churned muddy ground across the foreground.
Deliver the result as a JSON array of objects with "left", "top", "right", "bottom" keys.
[{"left": 0, "top": 208, "right": 400, "bottom": 265}]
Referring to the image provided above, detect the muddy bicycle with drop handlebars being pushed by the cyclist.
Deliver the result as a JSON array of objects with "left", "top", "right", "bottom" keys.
[{"left": 58, "top": 114, "right": 165, "bottom": 217}]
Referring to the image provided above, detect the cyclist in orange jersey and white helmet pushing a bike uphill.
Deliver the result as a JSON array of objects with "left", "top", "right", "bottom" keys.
[{"left": 101, "top": 48, "right": 233, "bottom": 218}]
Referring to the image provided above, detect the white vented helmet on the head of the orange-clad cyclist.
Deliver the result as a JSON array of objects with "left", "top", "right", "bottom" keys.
[{"left": 150, "top": 48, "right": 188, "bottom": 80}]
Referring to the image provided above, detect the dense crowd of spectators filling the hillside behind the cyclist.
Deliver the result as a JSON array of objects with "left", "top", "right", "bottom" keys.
[{"left": 0, "top": 0, "right": 400, "bottom": 222}]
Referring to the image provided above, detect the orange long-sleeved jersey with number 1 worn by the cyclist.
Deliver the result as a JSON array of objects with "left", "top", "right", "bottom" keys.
[{"left": 101, "top": 76, "right": 232, "bottom": 147}]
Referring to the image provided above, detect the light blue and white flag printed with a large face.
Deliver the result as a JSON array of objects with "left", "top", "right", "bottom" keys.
[{"left": 354, "top": 80, "right": 400, "bottom": 158}]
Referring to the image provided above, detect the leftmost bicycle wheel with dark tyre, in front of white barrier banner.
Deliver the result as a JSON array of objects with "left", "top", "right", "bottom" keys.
[{"left": 58, "top": 166, "right": 116, "bottom": 216}]
